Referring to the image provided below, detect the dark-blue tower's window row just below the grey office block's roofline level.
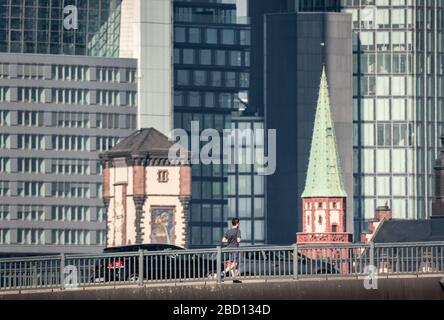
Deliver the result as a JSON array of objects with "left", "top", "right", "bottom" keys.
[{"left": 176, "top": 70, "right": 250, "bottom": 89}]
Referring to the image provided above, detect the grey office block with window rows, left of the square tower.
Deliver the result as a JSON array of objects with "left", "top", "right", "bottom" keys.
[{"left": 0, "top": 54, "right": 137, "bottom": 255}]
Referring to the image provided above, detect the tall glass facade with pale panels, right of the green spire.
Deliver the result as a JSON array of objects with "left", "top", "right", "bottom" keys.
[{"left": 342, "top": 0, "right": 444, "bottom": 233}]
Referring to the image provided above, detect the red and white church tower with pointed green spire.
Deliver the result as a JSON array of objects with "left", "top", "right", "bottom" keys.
[{"left": 297, "top": 65, "right": 352, "bottom": 244}]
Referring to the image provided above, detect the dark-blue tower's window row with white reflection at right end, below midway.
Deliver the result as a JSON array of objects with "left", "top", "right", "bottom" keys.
[{"left": 174, "top": 91, "right": 248, "bottom": 110}]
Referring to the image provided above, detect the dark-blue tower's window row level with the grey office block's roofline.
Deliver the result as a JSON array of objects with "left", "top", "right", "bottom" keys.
[{"left": 174, "top": 48, "right": 250, "bottom": 67}]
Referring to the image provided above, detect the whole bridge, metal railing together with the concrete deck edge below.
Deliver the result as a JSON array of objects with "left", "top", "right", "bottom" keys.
[{"left": 0, "top": 242, "right": 444, "bottom": 300}]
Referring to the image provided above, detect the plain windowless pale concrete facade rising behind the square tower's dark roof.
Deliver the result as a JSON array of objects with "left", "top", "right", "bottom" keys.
[{"left": 120, "top": 0, "right": 173, "bottom": 136}]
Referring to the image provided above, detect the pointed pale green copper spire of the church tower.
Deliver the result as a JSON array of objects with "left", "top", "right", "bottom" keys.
[{"left": 302, "top": 65, "right": 347, "bottom": 198}]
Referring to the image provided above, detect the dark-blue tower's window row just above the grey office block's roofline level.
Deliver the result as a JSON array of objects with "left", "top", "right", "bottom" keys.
[{"left": 174, "top": 27, "right": 250, "bottom": 46}]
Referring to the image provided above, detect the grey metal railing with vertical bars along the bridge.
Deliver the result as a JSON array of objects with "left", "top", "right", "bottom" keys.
[{"left": 0, "top": 242, "right": 444, "bottom": 291}]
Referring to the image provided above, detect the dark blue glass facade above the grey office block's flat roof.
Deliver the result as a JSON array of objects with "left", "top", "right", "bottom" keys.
[{"left": 0, "top": 0, "right": 121, "bottom": 57}]
